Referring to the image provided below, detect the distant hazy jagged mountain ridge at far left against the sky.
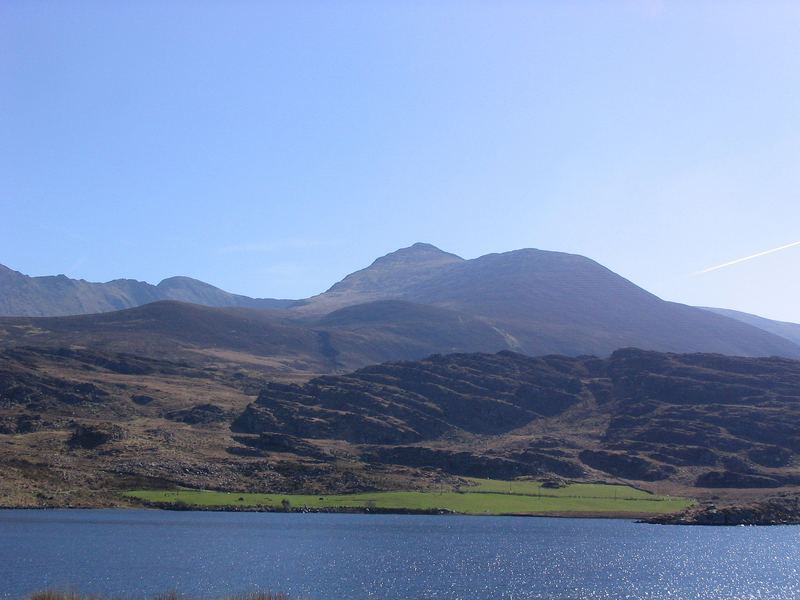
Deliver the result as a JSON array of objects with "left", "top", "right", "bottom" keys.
[{"left": 0, "top": 265, "right": 292, "bottom": 317}]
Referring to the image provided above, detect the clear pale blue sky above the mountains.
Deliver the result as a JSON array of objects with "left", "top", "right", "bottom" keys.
[{"left": 0, "top": 0, "right": 800, "bottom": 321}]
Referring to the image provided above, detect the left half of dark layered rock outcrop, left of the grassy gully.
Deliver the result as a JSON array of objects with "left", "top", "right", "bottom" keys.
[{"left": 234, "top": 352, "right": 584, "bottom": 444}]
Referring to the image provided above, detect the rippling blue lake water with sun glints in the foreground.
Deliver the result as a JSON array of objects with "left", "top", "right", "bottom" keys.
[{"left": 0, "top": 510, "right": 800, "bottom": 600}]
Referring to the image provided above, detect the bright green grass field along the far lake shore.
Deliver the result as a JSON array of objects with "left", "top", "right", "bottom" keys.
[{"left": 125, "top": 479, "right": 692, "bottom": 516}]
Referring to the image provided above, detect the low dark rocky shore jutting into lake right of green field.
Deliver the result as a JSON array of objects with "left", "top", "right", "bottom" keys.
[{"left": 642, "top": 495, "right": 800, "bottom": 525}]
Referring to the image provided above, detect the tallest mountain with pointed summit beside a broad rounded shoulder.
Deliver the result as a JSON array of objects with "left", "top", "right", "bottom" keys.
[{"left": 290, "top": 244, "right": 800, "bottom": 357}]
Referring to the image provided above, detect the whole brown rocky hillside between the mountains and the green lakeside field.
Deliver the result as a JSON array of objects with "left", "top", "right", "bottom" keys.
[{"left": 0, "top": 342, "right": 800, "bottom": 505}]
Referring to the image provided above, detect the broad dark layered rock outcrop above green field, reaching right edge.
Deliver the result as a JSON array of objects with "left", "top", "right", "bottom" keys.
[{"left": 233, "top": 349, "right": 800, "bottom": 488}]
